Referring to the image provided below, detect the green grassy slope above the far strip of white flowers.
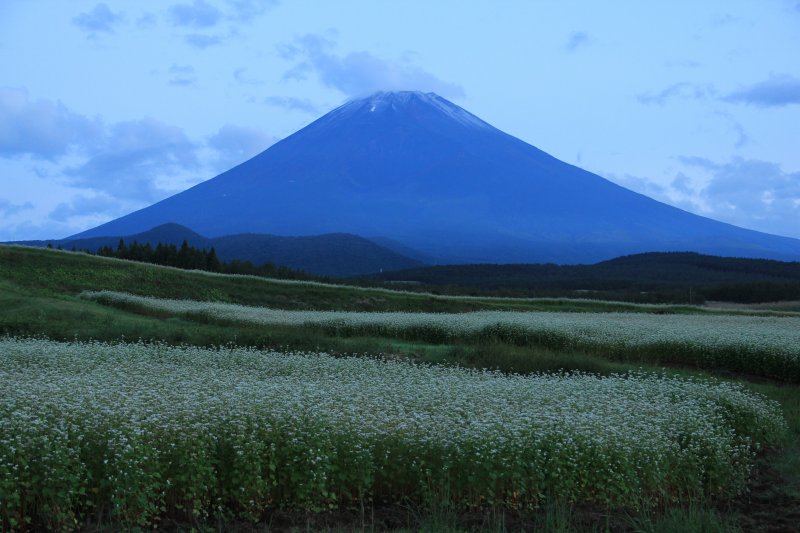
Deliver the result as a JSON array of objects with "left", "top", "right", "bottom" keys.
[{"left": 0, "top": 246, "right": 716, "bottom": 313}]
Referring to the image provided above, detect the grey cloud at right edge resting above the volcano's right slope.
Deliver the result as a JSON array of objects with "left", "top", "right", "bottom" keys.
[{"left": 680, "top": 157, "right": 800, "bottom": 237}]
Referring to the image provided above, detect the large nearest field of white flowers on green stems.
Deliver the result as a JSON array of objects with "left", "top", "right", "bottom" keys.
[{"left": 0, "top": 338, "right": 785, "bottom": 529}]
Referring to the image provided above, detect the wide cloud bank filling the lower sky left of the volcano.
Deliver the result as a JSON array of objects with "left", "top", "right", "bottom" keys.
[{"left": 0, "top": 93, "right": 286, "bottom": 239}]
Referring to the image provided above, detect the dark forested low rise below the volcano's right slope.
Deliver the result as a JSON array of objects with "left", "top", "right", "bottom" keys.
[{"left": 370, "top": 252, "right": 800, "bottom": 304}]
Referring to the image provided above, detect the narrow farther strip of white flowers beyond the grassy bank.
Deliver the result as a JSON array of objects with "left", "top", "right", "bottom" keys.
[{"left": 82, "top": 291, "right": 800, "bottom": 382}]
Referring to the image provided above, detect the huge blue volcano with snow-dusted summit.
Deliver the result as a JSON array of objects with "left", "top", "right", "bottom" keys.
[{"left": 75, "top": 92, "right": 800, "bottom": 263}]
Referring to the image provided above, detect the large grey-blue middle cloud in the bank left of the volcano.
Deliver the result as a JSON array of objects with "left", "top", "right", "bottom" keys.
[{"left": 63, "top": 119, "right": 199, "bottom": 201}]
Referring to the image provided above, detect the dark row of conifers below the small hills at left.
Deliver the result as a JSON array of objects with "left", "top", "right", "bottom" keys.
[{"left": 64, "top": 239, "right": 329, "bottom": 281}]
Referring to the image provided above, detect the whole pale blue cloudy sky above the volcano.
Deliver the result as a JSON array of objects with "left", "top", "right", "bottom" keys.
[{"left": 0, "top": 0, "right": 800, "bottom": 240}]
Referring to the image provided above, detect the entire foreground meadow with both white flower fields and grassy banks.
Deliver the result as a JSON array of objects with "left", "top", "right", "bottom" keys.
[{"left": 0, "top": 247, "right": 800, "bottom": 532}]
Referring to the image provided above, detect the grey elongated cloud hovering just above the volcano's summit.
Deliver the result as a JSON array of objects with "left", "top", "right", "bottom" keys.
[{"left": 279, "top": 34, "right": 464, "bottom": 98}]
